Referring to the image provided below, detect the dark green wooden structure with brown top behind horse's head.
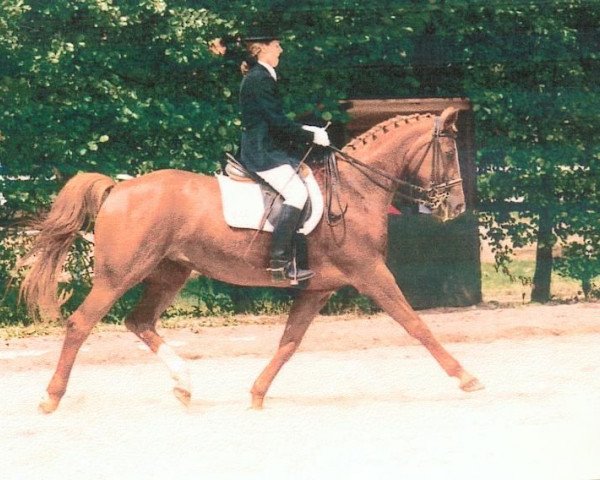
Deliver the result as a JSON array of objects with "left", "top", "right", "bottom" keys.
[{"left": 346, "top": 98, "right": 481, "bottom": 308}]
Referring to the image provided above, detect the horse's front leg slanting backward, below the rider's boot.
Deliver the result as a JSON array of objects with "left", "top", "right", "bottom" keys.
[{"left": 251, "top": 291, "right": 332, "bottom": 409}]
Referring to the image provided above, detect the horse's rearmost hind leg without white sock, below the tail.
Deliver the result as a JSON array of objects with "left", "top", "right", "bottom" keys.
[{"left": 40, "top": 282, "right": 122, "bottom": 413}]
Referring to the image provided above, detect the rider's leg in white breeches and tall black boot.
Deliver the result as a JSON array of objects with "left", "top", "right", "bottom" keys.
[{"left": 256, "top": 165, "right": 314, "bottom": 281}]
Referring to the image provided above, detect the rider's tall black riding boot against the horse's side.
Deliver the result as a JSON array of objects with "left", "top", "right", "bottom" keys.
[{"left": 269, "top": 203, "right": 315, "bottom": 282}]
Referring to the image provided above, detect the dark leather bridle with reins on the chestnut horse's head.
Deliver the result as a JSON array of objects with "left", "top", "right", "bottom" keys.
[{"left": 330, "top": 117, "right": 462, "bottom": 210}]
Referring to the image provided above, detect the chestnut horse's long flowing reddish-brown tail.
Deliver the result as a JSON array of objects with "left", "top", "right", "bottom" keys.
[{"left": 19, "top": 173, "right": 115, "bottom": 318}]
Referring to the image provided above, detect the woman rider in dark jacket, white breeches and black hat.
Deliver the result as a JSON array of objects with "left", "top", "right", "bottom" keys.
[{"left": 240, "top": 36, "right": 329, "bottom": 281}]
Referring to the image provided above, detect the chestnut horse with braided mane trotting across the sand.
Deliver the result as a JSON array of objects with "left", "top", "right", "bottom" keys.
[{"left": 21, "top": 108, "right": 483, "bottom": 413}]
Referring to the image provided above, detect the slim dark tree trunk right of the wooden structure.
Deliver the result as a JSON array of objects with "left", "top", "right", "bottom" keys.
[{"left": 531, "top": 207, "right": 555, "bottom": 303}]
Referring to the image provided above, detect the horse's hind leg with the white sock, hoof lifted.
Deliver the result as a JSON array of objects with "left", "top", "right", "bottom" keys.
[{"left": 125, "top": 260, "right": 192, "bottom": 406}]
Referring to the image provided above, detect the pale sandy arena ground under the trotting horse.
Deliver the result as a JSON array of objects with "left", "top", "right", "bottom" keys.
[{"left": 0, "top": 303, "right": 600, "bottom": 480}]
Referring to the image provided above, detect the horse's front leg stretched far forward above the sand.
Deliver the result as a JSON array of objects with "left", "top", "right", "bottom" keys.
[{"left": 355, "top": 262, "right": 484, "bottom": 392}]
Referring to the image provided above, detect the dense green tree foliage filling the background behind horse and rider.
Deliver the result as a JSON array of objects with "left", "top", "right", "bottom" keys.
[{"left": 0, "top": 0, "right": 600, "bottom": 324}]
